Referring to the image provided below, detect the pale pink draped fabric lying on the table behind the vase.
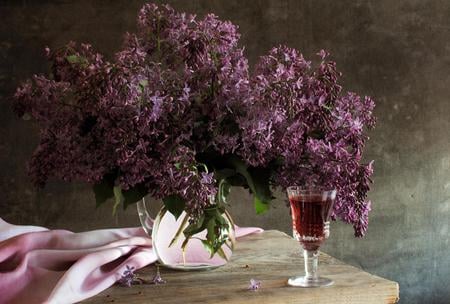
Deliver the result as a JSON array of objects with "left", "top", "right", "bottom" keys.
[{"left": 0, "top": 218, "right": 262, "bottom": 304}]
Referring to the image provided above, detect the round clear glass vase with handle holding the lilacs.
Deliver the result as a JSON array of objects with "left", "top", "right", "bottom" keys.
[{"left": 137, "top": 199, "right": 235, "bottom": 271}]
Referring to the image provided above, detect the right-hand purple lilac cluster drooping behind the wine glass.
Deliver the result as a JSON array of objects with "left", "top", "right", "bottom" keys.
[{"left": 239, "top": 46, "right": 375, "bottom": 236}]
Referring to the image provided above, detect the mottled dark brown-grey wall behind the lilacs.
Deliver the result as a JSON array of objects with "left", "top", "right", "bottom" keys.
[{"left": 0, "top": 0, "right": 450, "bottom": 303}]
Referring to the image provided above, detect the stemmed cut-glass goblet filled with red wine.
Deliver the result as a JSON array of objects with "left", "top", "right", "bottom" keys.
[{"left": 287, "top": 186, "right": 336, "bottom": 287}]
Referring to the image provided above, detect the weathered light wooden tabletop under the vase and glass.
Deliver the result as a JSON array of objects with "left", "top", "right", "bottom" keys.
[{"left": 83, "top": 230, "right": 399, "bottom": 304}]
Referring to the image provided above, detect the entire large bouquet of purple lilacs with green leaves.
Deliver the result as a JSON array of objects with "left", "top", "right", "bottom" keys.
[{"left": 14, "top": 4, "right": 374, "bottom": 252}]
